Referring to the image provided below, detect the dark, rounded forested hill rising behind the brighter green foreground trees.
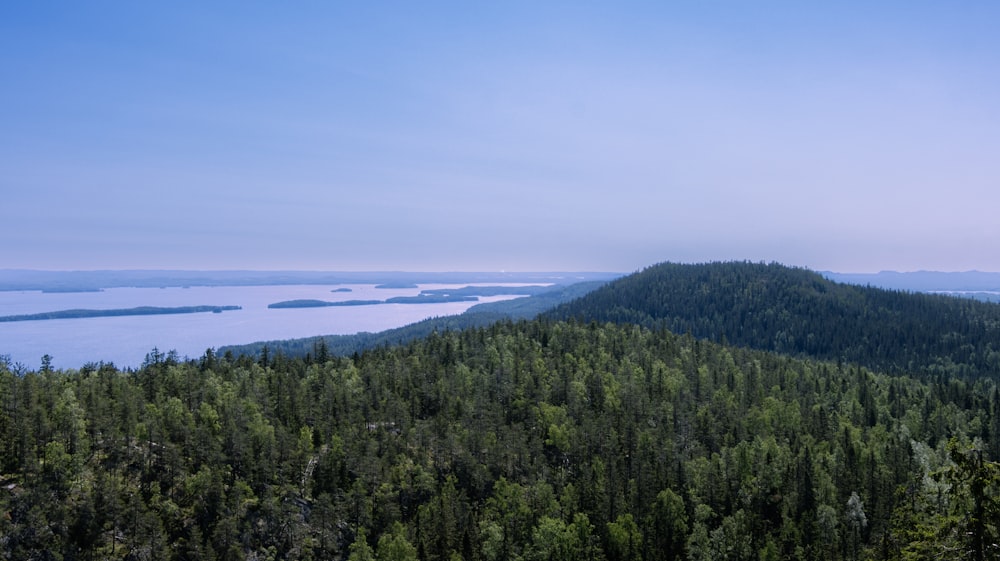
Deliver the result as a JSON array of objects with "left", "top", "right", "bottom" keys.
[{"left": 548, "top": 262, "right": 1000, "bottom": 378}]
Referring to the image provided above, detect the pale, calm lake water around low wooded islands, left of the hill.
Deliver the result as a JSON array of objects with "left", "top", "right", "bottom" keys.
[{"left": 0, "top": 284, "right": 524, "bottom": 369}]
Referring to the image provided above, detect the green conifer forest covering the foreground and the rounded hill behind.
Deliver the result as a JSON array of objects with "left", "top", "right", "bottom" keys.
[{"left": 0, "top": 264, "right": 1000, "bottom": 561}]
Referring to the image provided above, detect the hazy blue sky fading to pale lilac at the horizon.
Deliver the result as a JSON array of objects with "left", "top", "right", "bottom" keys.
[{"left": 0, "top": 0, "right": 1000, "bottom": 272}]
